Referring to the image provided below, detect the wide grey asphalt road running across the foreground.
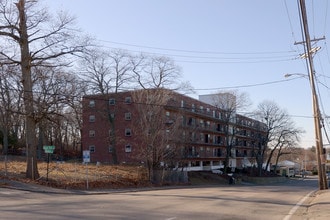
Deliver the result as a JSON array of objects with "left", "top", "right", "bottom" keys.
[{"left": 0, "top": 179, "right": 317, "bottom": 220}]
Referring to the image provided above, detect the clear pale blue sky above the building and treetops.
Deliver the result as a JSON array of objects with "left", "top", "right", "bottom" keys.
[{"left": 43, "top": 0, "right": 330, "bottom": 148}]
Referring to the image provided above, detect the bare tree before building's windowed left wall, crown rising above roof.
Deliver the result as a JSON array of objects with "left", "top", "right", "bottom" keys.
[{"left": 82, "top": 49, "right": 132, "bottom": 164}]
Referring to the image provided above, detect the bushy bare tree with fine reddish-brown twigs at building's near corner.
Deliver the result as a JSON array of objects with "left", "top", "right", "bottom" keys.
[{"left": 132, "top": 89, "right": 180, "bottom": 181}]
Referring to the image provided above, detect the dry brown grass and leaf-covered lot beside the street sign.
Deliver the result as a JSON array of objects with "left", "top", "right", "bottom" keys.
[{"left": 0, "top": 158, "right": 149, "bottom": 189}]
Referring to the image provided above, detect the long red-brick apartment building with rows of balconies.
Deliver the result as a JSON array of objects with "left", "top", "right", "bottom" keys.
[{"left": 82, "top": 89, "right": 265, "bottom": 171}]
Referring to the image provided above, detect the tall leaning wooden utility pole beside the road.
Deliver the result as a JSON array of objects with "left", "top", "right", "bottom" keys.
[{"left": 300, "top": 0, "right": 328, "bottom": 190}]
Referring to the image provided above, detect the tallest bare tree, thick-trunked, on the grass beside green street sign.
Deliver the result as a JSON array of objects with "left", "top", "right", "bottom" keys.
[{"left": 0, "top": 0, "right": 86, "bottom": 179}]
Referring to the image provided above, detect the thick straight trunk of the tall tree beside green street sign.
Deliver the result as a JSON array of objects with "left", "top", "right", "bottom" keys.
[{"left": 16, "top": 0, "right": 39, "bottom": 179}]
